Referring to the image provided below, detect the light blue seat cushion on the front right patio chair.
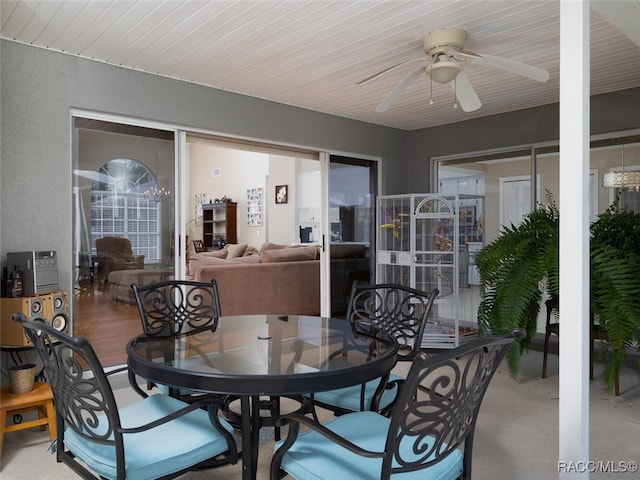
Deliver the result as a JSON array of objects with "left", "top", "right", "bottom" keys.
[{"left": 275, "top": 411, "right": 462, "bottom": 480}]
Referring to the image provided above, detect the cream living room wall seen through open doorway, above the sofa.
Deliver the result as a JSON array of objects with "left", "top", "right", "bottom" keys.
[{"left": 186, "top": 135, "right": 322, "bottom": 250}]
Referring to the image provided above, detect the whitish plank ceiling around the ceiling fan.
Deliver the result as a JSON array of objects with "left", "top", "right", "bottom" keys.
[{"left": 0, "top": 0, "right": 640, "bottom": 130}]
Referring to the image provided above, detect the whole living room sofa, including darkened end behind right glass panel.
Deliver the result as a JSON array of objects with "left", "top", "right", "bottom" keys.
[{"left": 189, "top": 243, "right": 373, "bottom": 316}]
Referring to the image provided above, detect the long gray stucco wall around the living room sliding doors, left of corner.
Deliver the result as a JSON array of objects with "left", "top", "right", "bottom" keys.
[{"left": 0, "top": 40, "right": 407, "bottom": 291}]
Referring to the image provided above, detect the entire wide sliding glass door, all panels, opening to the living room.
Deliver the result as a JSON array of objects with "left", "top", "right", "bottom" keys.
[{"left": 70, "top": 119, "right": 378, "bottom": 365}]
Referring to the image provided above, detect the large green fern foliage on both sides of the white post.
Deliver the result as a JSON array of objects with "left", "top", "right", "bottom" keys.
[{"left": 476, "top": 193, "right": 640, "bottom": 391}]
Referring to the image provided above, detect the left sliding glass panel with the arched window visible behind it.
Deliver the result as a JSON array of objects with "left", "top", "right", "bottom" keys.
[{"left": 71, "top": 117, "right": 176, "bottom": 365}]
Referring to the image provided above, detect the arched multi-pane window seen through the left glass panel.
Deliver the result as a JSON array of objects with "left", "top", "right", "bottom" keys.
[{"left": 91, "top": 158, "right": 160, "bottom": 262}]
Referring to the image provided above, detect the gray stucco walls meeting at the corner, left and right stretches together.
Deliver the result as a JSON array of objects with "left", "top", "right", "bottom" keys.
[{"left": 0, "top": 40, "right": 640, "bottom": 296}]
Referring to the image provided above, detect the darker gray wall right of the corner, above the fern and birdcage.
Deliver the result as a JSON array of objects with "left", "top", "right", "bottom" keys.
[{"left": 407, "top": 88, "right": 640, "bottom": 193}]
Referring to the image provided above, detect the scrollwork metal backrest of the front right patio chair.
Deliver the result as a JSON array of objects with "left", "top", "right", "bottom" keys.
[{"left": 381, "top": 330, "right": 525, "bottom": 478}]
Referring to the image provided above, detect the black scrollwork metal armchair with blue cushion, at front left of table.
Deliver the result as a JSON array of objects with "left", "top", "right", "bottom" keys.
[{"left": 12, "top": 313, "right": 237, "bottom": 480}]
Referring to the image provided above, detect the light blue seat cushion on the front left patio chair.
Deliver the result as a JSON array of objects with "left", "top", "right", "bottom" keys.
[{"left": 64, "top": 394, "right": 233, "bottom": 480}]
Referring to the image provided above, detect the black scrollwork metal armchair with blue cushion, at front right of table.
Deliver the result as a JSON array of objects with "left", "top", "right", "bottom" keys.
[{"left": 270, "top": 330, "right": 524, "bottom": 480}]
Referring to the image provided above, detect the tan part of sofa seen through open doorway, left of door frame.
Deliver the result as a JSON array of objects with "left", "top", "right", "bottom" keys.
[{"left": 189, "top": 244, "right": 320, "bottom": 315}]
